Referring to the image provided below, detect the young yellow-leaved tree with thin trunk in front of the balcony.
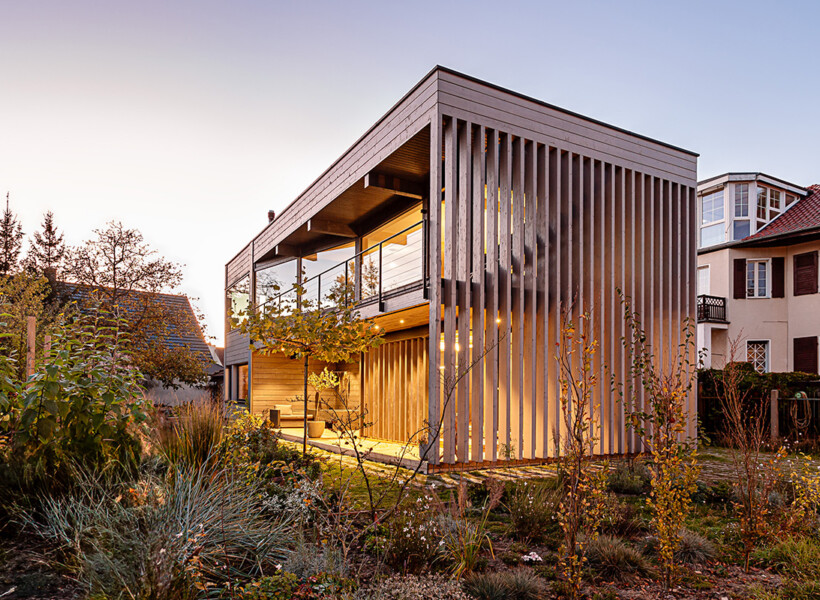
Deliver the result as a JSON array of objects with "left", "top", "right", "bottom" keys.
[{"left": 232, "top": 284, "right": 384, "bottom": 452}]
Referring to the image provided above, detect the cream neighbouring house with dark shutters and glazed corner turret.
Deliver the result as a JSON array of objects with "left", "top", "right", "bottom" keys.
[{"left": 697, "top": 173, "right": 820, "bottom": 373}]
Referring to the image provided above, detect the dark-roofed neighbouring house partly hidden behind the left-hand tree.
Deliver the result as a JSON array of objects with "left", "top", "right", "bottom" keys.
[{"left": 58, "top": 282, "right": 223, "bottom": 405}]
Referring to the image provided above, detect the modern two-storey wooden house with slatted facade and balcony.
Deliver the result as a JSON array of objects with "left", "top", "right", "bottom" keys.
[{"left": 225, "top": 67, "right": 697, "bottom": 465}]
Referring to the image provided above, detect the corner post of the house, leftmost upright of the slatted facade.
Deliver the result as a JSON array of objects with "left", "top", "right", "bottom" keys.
[{"left": 427, "top": 112, "right": 443, "bottom": 465}]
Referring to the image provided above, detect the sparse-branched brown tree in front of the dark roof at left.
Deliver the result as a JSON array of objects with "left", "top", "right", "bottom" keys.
[{"left": 65, "top": 221, "right": 206, "bottom": 387}]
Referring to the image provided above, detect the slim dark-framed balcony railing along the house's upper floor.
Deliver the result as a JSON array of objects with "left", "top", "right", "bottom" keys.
[{"left": 258, "top": 221, "right": 425, "bottom": 314}]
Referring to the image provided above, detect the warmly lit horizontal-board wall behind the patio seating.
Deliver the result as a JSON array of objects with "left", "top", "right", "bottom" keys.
[{"left": 251, "top": 353, "right": 361, "bottom": 419}]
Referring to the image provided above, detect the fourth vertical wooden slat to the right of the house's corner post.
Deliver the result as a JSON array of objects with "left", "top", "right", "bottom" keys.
[{"left": 484, "top": 130, "right": 500, "bottom": 461}]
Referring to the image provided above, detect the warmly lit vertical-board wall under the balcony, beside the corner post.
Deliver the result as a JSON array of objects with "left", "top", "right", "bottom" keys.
[{"left": 362, "top": 328, "right": 429, "bottom": 443}]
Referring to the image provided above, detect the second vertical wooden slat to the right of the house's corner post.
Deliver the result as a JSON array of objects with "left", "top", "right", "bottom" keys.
[{"left": 455, "top": 122, "right": 472, "bottom": 462}]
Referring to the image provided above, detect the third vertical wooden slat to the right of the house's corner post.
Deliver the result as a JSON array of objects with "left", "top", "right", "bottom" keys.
[{"left": 470, "top": 125, "right": 484, "bottom": 462}]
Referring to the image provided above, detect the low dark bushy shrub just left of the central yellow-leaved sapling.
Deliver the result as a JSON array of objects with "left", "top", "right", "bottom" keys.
[{"left": 506, "top": 481, "right": 561, "bottom": 542}]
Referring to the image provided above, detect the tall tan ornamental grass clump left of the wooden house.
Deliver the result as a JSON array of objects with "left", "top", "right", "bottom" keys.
[{"left": 154, "top": 394, "right": 225, "bottom": 469}]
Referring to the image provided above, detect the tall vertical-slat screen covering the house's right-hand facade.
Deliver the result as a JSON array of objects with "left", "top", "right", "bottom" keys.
[{"left": 428, "top": 114, "right": 696, "bottom": 464}]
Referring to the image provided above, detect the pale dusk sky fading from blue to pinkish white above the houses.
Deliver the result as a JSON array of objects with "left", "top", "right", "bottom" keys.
[{"left": 0, "top": 0, "right": 820, "bottom": 344}]
